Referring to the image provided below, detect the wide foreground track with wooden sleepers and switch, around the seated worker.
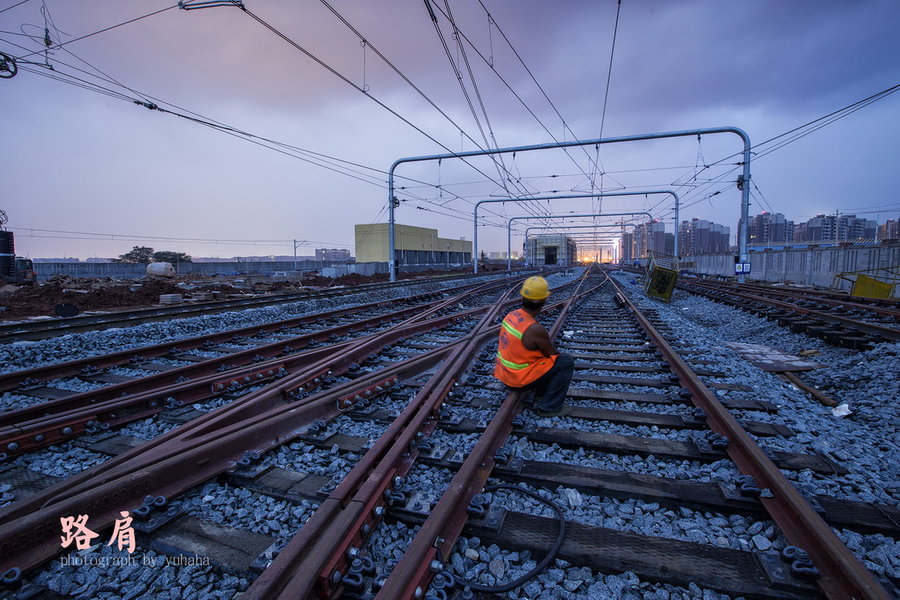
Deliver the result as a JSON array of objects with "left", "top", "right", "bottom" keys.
[{"left": 0, "top": 273, "right": 900, "bottom": 600}]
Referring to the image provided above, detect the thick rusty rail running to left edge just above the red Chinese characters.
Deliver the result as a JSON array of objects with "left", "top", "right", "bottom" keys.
[{"left": 0, "top": 348, "right": 446, "bottom": 572}]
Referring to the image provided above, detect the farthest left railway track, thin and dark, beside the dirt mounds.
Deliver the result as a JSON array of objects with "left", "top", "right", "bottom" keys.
[{"left": 0, "top": 274, "right": 492, "bottom": 344}]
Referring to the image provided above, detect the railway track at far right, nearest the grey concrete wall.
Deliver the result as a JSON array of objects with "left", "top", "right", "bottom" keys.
[{"left": 678, "top": 278, "right": 900, "bottom": 349}]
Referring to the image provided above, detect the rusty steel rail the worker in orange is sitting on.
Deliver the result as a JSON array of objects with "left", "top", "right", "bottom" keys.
[{"left": 372, "top": 272, "right": 609, "bottom": 600}]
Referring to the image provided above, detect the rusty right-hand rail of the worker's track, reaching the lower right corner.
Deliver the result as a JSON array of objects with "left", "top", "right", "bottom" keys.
[{"left": 613, "top": 283, "right": 888, "bottom": 600}]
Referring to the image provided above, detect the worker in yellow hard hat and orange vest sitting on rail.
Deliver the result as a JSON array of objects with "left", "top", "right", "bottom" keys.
[{"left": 494, "top": 277, "right": 575, "bottom": 417}]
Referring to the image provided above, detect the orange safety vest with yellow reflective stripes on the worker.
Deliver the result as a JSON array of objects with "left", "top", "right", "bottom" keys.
[{"left": 494, "top": 308, "right": 556, "bottom": 387}]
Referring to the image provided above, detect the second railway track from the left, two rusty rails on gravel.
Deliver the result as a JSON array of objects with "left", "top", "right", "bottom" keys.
[{"left": 0, "top": 283, "right": 520, "bottom": 458}]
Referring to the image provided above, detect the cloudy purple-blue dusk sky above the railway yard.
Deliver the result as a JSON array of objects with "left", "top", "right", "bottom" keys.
[{"left": 0, "top": 0, "right": 900, "bottom": 258}]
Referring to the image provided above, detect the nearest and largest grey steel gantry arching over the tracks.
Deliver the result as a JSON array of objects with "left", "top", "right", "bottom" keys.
[{"left": 388, "top": 127, "right": 750, "bottom": 281}]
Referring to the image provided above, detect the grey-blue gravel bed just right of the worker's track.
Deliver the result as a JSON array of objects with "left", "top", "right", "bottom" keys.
[{"left": 619, "top": 275, "right": 900, "bottom": 575}]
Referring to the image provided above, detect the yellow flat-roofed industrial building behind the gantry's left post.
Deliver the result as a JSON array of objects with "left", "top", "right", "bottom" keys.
[{"left": 354, "top": 223, "right": 472, "bottom": 266}]
